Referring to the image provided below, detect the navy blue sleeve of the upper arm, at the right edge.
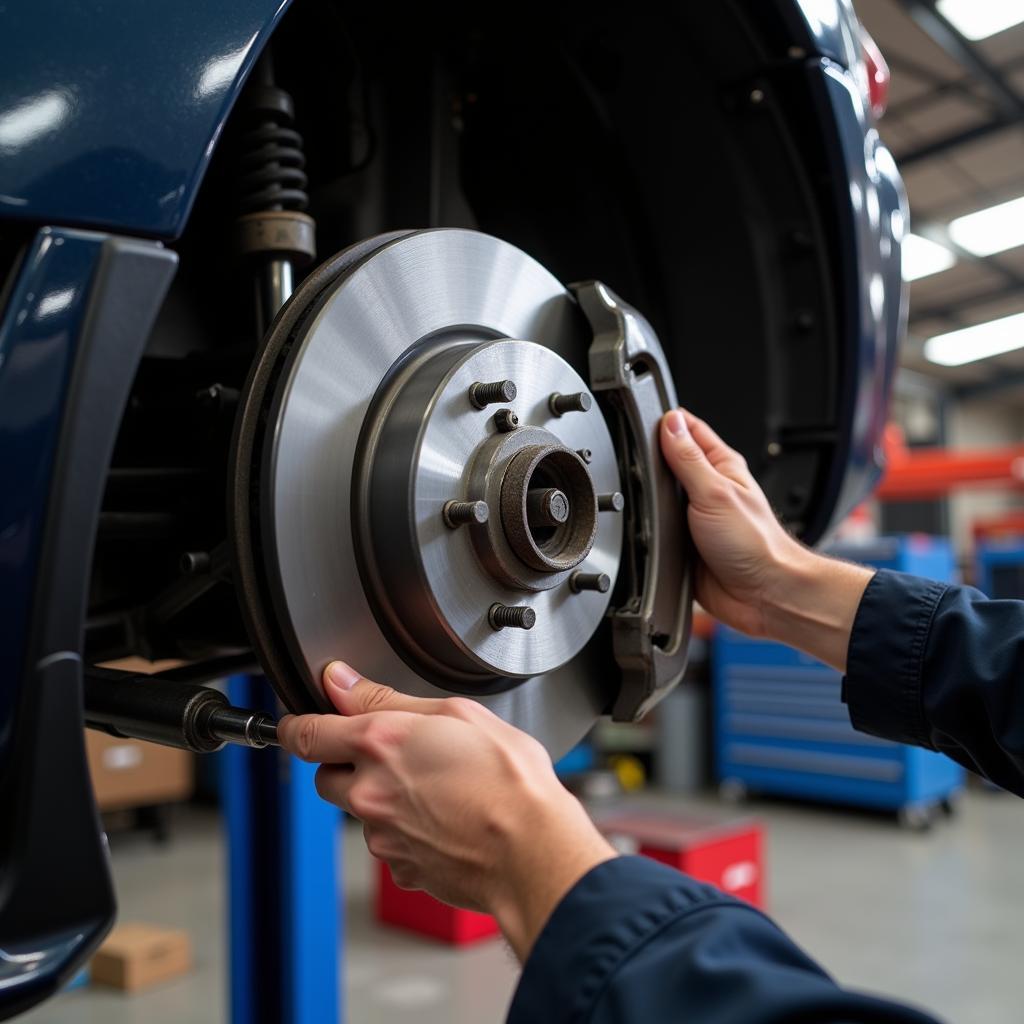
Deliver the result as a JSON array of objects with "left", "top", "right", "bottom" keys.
[{"left": 843, "top": 570, "right": 1024, "bottom": 796}]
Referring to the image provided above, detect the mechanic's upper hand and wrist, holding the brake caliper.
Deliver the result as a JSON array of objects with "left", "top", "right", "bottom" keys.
[{"left": 662, "top": 410, "right": 872, "bottom": 671}]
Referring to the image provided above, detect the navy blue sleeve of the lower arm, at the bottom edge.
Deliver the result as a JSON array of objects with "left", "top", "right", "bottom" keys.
[{"left": 508, "top": 857, "right": 934, "bottom": 1024}]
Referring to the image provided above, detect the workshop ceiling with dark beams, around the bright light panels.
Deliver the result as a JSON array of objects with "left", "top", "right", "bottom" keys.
[{"left": 854, "top": 0, "right": 1024, "bottom": 397}]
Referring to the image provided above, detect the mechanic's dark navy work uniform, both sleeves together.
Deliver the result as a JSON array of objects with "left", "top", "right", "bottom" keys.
[{"left": 509, "top": 571, "right": 1024, "bottom": 1024}]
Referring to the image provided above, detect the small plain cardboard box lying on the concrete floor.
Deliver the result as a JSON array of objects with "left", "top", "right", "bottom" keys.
[{"left": 89, "top": 924, "right": 191, "bottom": 992}]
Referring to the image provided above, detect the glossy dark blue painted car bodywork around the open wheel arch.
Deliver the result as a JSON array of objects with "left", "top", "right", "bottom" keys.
[{"left": 0, "top": 0, "right": 906, "bottom": 1017}]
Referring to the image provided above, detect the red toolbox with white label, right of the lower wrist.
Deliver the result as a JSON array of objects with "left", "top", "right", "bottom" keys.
[{"left": 596, "top": 811, "right": 765, "bottom": 909}]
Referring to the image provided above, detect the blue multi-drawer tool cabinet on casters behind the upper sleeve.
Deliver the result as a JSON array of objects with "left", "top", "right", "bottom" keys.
[{"left": 713, "top": 537, "right": 965, "bottom": 824}]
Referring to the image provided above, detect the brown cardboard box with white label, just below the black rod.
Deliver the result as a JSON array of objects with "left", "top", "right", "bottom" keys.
[{"left": 85, "top": 729, "right": 194, "bottom": 811}]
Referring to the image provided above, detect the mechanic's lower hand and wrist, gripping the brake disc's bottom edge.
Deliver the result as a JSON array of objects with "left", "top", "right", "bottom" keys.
[{"left": 279, "top": 662, "right": 614, "bottom": 958}]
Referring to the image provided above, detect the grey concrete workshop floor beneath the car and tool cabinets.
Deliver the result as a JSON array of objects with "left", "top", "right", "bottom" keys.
[{"left": 20, "top": 792, "right": 1024, "bottom": 1024}]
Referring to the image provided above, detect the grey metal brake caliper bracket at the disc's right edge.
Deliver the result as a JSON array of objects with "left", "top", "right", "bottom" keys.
[{"left": 570, "top": 282, "right": 693, "bottom": 722}]
